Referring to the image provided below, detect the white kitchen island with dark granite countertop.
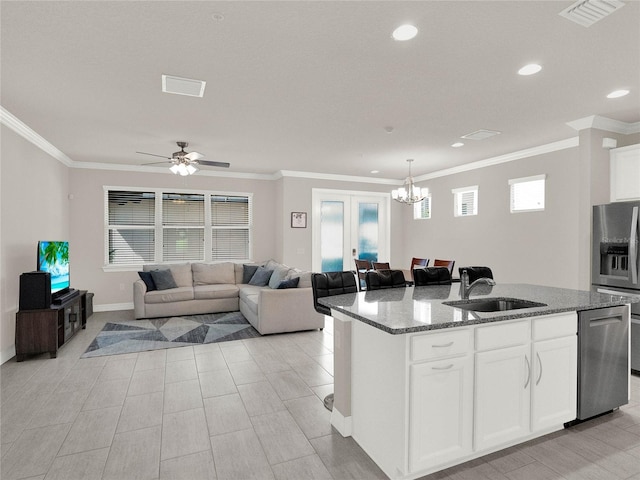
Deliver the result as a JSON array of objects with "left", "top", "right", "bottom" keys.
[{"left": 319, "top": 284, "right": 635, "bottom": 479}]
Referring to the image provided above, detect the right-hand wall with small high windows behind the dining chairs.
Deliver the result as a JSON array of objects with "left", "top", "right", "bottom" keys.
[{"left": 404, "top": 148, "right": 579, "bottom": 288}]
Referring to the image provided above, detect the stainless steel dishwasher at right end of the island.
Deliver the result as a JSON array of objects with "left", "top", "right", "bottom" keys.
[{"left": 578, "top": 305, "right": 630, "bottom": 420}]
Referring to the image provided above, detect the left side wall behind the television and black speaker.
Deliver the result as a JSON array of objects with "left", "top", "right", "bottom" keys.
[{"left": 0, "top": 126, "right": 73, "bottom": 363}]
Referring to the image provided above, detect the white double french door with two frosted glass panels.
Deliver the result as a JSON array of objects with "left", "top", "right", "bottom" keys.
[{"left": 312, "top": 189, "right": 390, "bottom": 272}]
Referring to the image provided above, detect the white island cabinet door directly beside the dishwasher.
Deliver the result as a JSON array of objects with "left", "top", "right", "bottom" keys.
[{"left": 531, "top": 335, "right": 578, "bottom": 432}]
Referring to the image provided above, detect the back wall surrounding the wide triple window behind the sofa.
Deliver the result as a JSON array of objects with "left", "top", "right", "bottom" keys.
[{"left": 69, "top": 168, "right": 277, "bottom": 310}]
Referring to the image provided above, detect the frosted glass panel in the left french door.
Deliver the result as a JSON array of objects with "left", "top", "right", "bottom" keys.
[{"left": 320, "top": 201, "right": 344, "bottom": 272}]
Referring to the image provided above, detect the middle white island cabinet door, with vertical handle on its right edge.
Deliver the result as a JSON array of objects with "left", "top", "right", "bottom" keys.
[{"left": 474, "top": 344, "right": 532, "bottom": 450}]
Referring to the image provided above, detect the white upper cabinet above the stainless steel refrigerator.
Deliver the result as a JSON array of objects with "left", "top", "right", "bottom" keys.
[{"left": 609, "top": 144, "right": 640, "bottom": 202}]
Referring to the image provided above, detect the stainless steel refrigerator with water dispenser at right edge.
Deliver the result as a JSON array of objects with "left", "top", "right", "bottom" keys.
[{"left": 591, "top": 201, "right": 640, "bottom": 374}]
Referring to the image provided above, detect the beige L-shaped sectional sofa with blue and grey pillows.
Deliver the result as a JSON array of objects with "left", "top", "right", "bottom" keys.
[{"left": 133, "top": 260, "right": 324, "bottom": 335}]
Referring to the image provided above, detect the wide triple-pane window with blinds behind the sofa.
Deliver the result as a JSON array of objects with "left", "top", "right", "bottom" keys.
[{"left": 105, "top": 187, "right": 252, "bottom": 267}]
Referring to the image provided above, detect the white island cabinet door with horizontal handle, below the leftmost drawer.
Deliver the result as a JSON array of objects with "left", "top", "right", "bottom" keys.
[{"left": 409, "top": 355, "right": 473, "bottom": 472}]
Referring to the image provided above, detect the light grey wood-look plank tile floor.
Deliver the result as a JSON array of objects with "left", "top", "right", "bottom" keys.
[{"left": 0, "top": 312, "right": 640, "bottom": 480}]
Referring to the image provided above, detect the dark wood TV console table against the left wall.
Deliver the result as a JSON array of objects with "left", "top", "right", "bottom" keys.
[{"left": 16, "top": 290, "right": 87, "bottom": 362}]
